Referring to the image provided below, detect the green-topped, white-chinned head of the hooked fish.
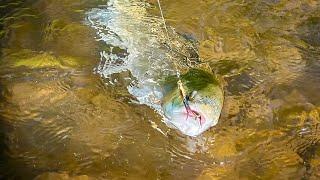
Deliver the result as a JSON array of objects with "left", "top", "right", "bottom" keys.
[{"left": 162, "top": 69, "right": 223, "bottom": 136}]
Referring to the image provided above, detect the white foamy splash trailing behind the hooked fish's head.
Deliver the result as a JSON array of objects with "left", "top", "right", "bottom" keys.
[{"left": 87, "top": 0, "right": 195, "bottom": 114}]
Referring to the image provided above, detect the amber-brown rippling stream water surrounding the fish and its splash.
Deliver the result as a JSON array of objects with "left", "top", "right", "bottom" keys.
[{"left": 0, "top": 0, "right": 320, "bottom": 179}]
